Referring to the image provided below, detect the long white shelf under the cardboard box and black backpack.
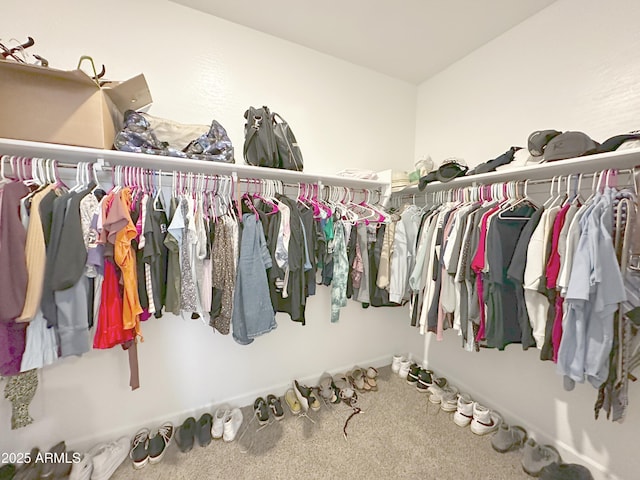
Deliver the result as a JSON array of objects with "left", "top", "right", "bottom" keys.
[{"left": 0, "top": 138, "right": 388, "bottom": 190}]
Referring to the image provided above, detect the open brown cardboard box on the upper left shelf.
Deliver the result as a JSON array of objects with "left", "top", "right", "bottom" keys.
[{"left": 0, "top": 60, "right": 152, "bottom": 149}]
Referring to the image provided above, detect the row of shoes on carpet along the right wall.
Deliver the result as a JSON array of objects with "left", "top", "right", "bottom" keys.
[{"left": 391, "top": 355, "right": 593, "bottom": 480}]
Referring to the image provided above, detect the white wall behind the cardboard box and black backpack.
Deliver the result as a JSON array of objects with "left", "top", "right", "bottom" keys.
[{"left": 0, "top": 0, "right": 423, "bottom": 452}]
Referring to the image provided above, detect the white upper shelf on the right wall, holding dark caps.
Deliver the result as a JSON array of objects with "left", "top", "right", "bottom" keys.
[{"left": 395, "top": 148, "right": 640, "bottom": 196}]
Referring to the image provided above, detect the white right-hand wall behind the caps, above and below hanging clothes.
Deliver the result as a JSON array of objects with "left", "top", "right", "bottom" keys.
[{"left": 415, "top": 0, "right": 640, "bottom": 479}]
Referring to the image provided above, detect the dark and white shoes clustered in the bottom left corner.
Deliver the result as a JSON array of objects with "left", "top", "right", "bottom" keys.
[{"left": 0, "top": 437, "right": 129, "bottom": 480}]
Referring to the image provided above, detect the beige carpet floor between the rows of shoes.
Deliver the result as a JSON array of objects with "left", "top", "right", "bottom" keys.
[{"left": 112, "top": 367, "right": 531, "bottom": 480}]
